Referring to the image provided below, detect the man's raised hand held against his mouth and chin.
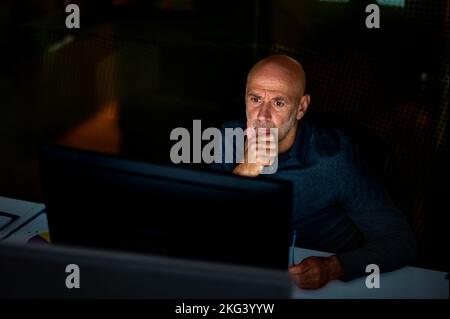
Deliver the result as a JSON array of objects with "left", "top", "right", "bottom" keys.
[{"left": 233, "top": 128, "right": 278, "bottom": 177}]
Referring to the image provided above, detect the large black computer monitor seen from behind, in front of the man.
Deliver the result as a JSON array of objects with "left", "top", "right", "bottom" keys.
[{"left": 40, "top": 146, "right": 292, "bottom": 270}]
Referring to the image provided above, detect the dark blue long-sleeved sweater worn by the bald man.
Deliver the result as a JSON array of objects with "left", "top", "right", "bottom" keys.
[{"left": 212, "top": 120, "right": 416, "bottom": 280}]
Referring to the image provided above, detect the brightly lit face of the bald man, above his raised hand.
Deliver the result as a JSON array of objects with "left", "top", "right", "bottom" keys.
[{"left": 245, "top": 66, "right": 300, "bottom": 142}]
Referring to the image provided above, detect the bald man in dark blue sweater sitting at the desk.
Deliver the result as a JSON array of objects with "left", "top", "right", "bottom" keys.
[{"left": 213, "top": 55, "right": 416, "bottom": 289}]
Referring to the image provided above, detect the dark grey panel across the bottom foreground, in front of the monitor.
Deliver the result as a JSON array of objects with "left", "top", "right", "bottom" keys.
[{"left": 0, "top": 242, "right": 293, "bottom": 299}]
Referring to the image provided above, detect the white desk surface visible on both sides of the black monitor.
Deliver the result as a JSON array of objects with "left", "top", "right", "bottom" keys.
[{"left": 0, "top": 197, "right": 449, "bottom": 299}]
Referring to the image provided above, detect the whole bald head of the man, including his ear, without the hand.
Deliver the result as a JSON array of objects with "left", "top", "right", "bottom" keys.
[{"left": 245, "top": 55, "right": 310, "bottom": 152}]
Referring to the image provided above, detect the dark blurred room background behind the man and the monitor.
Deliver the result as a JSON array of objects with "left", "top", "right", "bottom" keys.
[{"left": 0, "top": 0, "right": 449, "bottom": 271}]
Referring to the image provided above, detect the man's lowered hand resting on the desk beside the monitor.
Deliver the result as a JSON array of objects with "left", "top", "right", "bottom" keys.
[{"left": 289, "top": 255, "right": 344, "bottom": 289}]
